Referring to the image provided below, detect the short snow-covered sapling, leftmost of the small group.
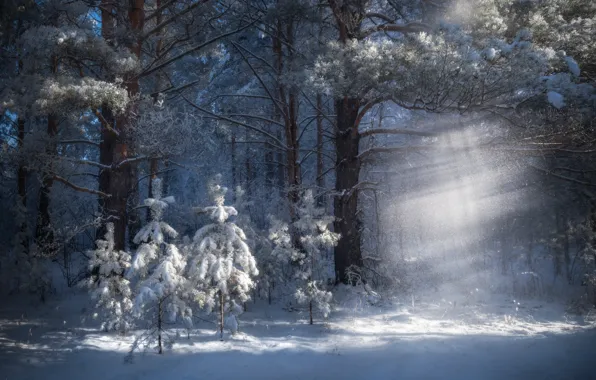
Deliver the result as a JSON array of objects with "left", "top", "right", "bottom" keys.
[{"left": 87, "top": 223, "right": 132, "bottom": 333}]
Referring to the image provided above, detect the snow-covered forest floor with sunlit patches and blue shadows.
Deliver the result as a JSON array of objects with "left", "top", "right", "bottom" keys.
[{"left": 0, "top": 289, "right": 596, "bottom": 380}]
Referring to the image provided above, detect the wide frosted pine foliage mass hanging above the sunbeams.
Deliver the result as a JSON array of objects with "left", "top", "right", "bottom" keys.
[{"left": 310, "top": 27, "right": 548, "bottom": 111}]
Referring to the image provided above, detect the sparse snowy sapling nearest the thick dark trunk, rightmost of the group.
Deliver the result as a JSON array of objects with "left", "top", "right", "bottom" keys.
[{"left": 271, "top": 190, "right": 339, "bottom": 325}]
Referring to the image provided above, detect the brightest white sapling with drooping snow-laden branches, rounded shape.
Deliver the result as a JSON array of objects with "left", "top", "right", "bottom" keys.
[{"left": 188, "top": 176, "right": 259, "bottom": 339}]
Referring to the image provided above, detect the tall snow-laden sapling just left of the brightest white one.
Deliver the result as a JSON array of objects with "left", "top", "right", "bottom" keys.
[{"left": 128, "top": 179, "right": 192, "bottom": 354}]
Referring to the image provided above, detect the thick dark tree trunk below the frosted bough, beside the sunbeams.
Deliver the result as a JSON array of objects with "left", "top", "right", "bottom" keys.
[{"left": 333, "top": 97, "right": 362, "bottom": 283}]
